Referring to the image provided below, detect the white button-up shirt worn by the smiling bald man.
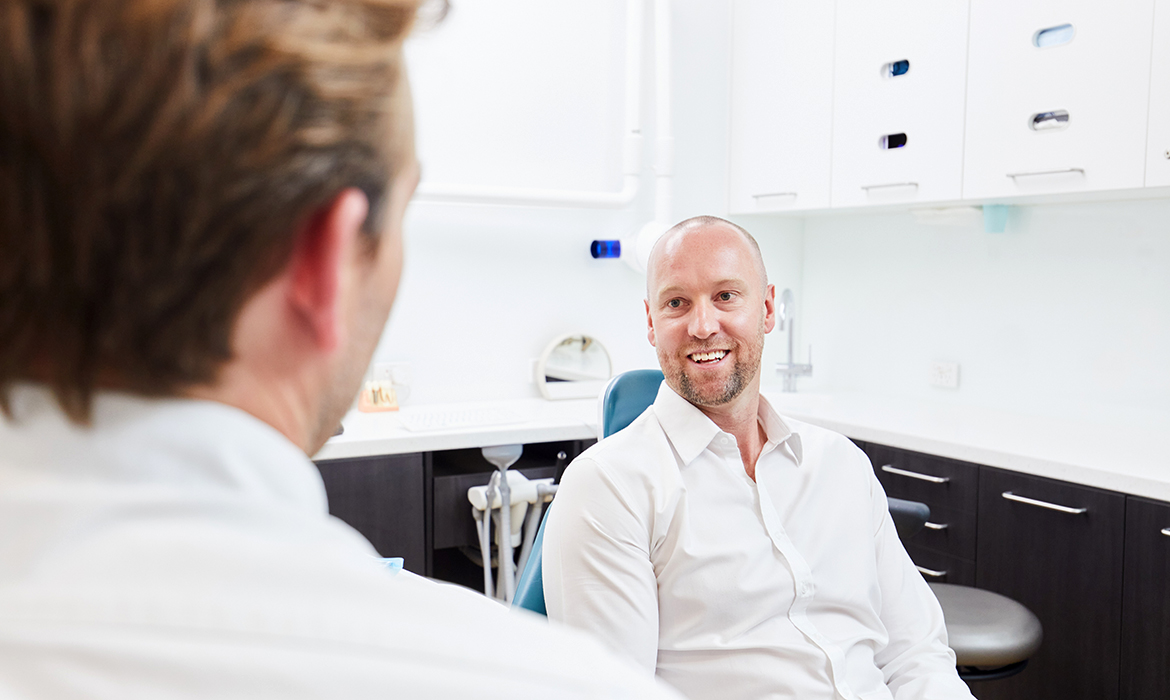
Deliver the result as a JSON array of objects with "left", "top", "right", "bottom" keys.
[{"left": 543, "top": 384, "right": 971, "bottom": 700}]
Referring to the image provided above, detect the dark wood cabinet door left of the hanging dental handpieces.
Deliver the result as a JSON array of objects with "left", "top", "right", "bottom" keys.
[{"left": 317, "top": 453, "right": 431, "bottom": 576}]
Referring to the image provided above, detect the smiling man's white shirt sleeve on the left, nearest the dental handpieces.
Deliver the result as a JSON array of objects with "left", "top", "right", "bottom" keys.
[{"left": 542, "top": 458, "right": 659, "bottom": 674}]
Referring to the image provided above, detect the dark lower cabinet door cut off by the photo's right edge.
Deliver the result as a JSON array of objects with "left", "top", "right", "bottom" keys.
[{"left": 1121, "top": 496, "right": 1170, "bottom": 700}]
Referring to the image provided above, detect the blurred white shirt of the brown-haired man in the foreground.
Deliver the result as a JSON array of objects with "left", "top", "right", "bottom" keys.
[{"left": 0, "top": 389, "right": 676, "bottom": 700}]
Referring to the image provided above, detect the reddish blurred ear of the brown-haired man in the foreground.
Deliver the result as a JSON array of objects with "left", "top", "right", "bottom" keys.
[{"left": 285, "top": 187, "right": 370, "bottom": 352}]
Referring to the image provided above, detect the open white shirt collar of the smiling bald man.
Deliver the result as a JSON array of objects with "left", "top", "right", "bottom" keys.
[{"left": 654, "top": 382, "right": 804, "bottom": 466}]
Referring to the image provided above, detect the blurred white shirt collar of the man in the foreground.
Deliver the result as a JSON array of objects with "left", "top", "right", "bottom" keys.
[{"left": 0, "top": 385, "right": 328, "bottom": 513}]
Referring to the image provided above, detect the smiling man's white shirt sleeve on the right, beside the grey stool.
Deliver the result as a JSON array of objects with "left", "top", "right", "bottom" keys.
[{"left": 870, "top": 472, "right": 973, "bottom": 700}]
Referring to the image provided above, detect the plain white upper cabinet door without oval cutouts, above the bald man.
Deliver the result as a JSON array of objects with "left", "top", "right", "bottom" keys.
[{"left": 729, "top": 0, "right": 833, "bottom": 214}]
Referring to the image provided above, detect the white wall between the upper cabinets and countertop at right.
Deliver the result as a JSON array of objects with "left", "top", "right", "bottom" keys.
[{"left": 801, "top": 200, "right": 1170, "bottom": 426}]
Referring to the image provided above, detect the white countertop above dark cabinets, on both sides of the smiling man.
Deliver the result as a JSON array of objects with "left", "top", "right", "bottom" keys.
[{"left": 314, "top": 387, "right": 1170, "bottom": 501}]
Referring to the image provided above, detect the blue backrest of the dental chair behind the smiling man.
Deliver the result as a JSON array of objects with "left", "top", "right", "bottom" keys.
[{"left": 512, "top": 370, "right": 662, "bottom": 615}]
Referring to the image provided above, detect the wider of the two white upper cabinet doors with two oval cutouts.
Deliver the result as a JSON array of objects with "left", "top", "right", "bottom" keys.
[{"left": 963, "top": 0, "right": 1154, "bottom": 199}]
